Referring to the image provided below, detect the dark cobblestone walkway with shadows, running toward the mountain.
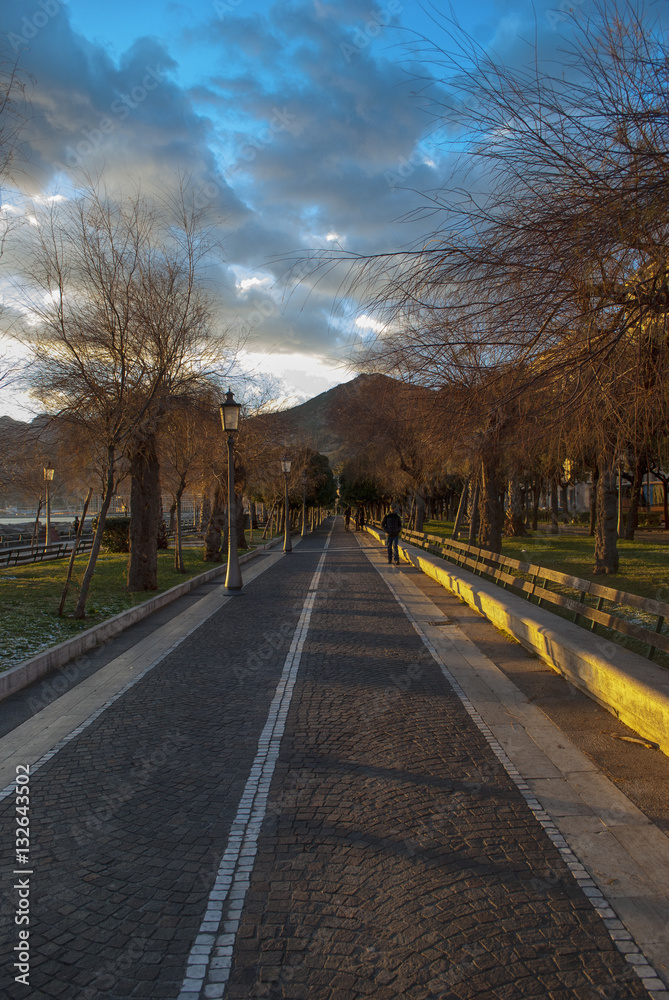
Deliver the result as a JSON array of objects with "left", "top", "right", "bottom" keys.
[{"left": 0, "top": 520, "right": 669, "bottom": 1000}]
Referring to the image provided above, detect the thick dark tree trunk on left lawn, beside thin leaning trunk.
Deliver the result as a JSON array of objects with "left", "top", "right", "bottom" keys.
[{"left": 128, "top": 431, "right": 162, "bottom": 591}]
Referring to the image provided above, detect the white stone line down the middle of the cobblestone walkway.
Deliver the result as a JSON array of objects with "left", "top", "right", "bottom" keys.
[{"left": 179, "top": 524, "right": 338, "bottom": 1000}]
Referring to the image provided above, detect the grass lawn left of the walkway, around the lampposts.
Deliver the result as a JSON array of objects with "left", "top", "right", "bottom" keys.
[{"left": 0, "top": 531, "right": 270, "bottom": 670}]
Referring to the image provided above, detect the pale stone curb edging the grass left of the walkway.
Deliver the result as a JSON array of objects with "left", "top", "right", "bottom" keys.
[{"left": 0, "top": 536, "right": 283, "bottom": 701}]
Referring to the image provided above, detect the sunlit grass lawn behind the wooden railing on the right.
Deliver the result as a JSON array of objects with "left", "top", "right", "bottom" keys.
[{"left": 425, "top": 521, "right": 669, "bottom": 601}]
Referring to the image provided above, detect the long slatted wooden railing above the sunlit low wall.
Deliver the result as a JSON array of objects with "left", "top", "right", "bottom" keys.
[{"left": 370, "top": 521, "right": 669, "bottom": 660}]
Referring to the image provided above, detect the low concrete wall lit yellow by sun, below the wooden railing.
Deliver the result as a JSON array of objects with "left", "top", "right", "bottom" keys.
[{"left": 367, "top": 527, "right": 669, "bottom": 754}]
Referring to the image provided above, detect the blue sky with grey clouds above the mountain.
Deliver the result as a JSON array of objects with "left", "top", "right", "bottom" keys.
[{"left": 0, "top": 0, "right": 590, "bottom": 419}]
